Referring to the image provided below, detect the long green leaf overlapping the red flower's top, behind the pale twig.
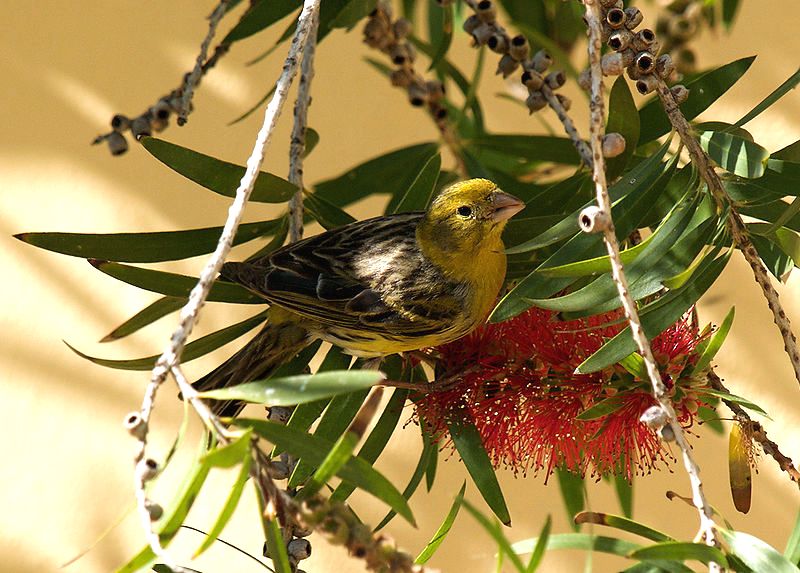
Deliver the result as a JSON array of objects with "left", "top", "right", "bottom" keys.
[{"left": 576, "top": 252, "right": 730, "bottom": 374}]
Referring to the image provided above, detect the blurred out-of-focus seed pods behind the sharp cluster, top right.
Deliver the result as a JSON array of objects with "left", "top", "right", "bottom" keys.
[{"left": 656, "top": 0, "right": 707, "bottom": 74}]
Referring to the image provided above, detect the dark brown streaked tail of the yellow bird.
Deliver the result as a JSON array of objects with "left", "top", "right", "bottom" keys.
[{"left": 194, "top": 307, "right": 312, "bottom": 416}]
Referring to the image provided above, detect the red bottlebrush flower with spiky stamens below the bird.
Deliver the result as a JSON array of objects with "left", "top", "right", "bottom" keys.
[{"left": 415, "top": 308, "right": 702, "bottom": 478}]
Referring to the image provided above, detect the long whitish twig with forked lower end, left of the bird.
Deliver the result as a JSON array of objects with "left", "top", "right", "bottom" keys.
[{"left": 130, "top": 0, "right": 320, "bottom": 569}]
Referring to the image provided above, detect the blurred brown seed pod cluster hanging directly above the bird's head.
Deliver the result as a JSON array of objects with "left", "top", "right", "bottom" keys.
[{"left": 363, "top": 3, "right": 447, "bottom": 126}]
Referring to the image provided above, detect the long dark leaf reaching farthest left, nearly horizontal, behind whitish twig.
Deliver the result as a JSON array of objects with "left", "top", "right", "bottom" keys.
[{"left": 14, "top": 219, "right": 281, "bottom": 263}]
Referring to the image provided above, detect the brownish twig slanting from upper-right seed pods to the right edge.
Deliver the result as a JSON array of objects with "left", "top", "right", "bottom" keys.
[{"left": 656, "top": 79, "right": 800, "bottom": 383}]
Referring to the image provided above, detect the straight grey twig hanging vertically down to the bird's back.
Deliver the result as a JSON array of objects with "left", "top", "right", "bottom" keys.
[{"left": 289, "top": 11, "right": 319, "bottom": 243}]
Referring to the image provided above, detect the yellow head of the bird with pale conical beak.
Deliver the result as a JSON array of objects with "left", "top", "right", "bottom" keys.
[{"left": 417, "top": 179, "right": 525, "bottom": 280}]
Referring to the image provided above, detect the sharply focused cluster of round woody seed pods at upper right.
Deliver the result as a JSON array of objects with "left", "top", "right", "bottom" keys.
[{"left": 592, "top": 0, "right": 689, "bottom": 103}]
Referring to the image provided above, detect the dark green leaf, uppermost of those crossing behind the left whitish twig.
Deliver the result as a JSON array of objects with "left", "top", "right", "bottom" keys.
[{"left": 139, "top": 137, "right": 297, "bottom": 203}]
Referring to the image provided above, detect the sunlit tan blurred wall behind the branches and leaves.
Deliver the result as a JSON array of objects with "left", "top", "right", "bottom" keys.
[{"left": 0, "top": 0, "right": 800, "bottom": 573}]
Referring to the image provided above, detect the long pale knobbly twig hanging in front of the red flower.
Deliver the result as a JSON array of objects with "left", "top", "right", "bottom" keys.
[{"left": 583, "top": 0, "right": 720, "bottom": 556}]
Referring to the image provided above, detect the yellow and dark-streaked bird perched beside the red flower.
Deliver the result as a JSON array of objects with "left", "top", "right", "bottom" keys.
[{"left": 195, "top": 179, "right": 525, "bottom": 415}]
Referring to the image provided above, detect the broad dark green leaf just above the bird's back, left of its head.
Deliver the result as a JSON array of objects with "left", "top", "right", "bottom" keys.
[{"left": 314, "top": 143, "right": 438, "bottom": 207}]
